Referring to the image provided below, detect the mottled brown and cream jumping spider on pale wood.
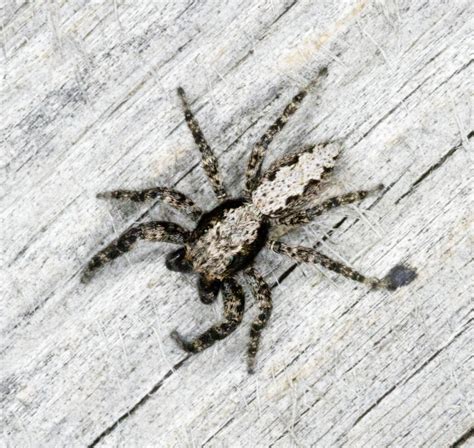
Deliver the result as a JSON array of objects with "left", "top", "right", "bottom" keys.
[{"left": 82, "top": 68, "right": 416, "bottom": 373}]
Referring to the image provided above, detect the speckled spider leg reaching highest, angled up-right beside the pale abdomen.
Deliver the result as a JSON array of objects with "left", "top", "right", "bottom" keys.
[{"left": 245, "top": 68, "right": 327, "bottom": 196}]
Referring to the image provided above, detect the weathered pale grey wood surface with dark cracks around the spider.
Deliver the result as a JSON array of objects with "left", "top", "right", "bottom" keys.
[{"left": 0, "top": 0, "right": 473, "bottom": 447}]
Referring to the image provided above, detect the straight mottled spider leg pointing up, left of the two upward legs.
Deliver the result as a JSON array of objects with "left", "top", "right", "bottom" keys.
[{"left": 178, "top": 87, "right": 227, "bottom": 200}]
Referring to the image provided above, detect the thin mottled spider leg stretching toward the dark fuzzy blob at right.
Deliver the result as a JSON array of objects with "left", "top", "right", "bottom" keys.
[{"left": 267, "top": 241, "right": 388, "bottom": 288}]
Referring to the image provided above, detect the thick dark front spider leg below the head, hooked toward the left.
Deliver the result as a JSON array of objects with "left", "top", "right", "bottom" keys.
[{"left": 171, "top": 278, "right": 245, "bottom": 353}]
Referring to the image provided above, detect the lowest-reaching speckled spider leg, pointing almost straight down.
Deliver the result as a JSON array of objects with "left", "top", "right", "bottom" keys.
[{"left": 245, "top": 268, "right": 273, "bottom": 373}]
